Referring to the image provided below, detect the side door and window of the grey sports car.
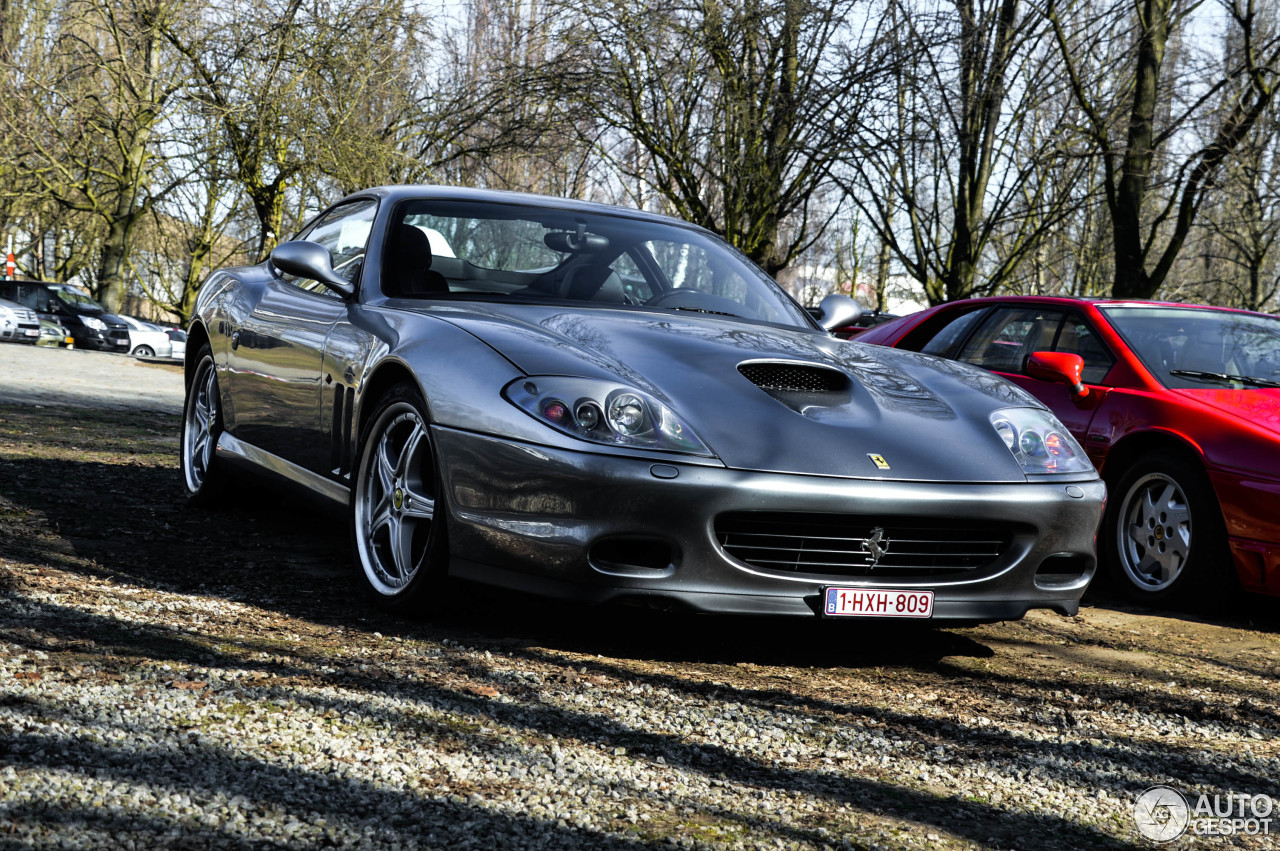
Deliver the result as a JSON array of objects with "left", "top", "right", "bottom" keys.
[{"left": 228, "top": 200, "right": 376, "bottom": 472}]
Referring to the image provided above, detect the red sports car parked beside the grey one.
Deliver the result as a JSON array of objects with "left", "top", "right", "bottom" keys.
[{"left": 858, "top": 296, "right": 1280, "bottom": 605}]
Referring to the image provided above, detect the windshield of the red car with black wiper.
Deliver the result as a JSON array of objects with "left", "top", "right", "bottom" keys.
[{"left": 1098, "top": 305, "right": 1280, "bottom": 389}]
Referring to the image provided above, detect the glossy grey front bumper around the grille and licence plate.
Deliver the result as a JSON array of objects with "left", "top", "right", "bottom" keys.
[{"left": 433, "top": 427, "right": 1106, "bottom": 621}]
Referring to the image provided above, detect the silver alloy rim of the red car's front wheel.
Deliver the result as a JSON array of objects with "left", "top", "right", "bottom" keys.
[{"left": 1115, "top": 471, "right": 1192, "bottom": 594}]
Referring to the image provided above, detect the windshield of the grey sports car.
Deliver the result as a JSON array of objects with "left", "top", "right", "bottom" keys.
[{"left": 381, "top": 201, "right": 814, "bottom": 329}]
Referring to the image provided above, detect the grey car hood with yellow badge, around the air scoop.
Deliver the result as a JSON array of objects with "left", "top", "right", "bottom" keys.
[{"left": 426, "top": 305, "right": 1059, "bottom": 482}]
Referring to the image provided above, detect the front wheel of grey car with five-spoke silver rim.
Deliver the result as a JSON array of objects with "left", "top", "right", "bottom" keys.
[{"left": 351, "top": 384, "right": 449, "bottom": 614}]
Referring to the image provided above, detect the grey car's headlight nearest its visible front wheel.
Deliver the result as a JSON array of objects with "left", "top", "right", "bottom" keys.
[{"left": 502, "top": 375, "right": 712, "bottom": 456}]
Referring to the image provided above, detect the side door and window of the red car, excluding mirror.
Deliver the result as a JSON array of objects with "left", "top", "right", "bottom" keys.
[{"left": 954, "top": 305, "right": 1115, "bottom": 449}]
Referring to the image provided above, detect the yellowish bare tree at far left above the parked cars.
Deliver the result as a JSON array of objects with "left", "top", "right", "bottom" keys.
[{"left": 0, "top": 0, "right": 182, "bottom": 308}]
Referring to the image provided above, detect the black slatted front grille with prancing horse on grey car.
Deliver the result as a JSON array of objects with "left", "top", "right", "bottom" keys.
[{"left": 716, "top": 512, "right": 1014, "bottom": 576}]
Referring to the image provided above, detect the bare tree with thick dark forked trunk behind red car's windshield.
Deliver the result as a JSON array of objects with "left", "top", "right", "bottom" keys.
[{"left": 1044, "top": 0, "right": 1280, "bottom": 298}]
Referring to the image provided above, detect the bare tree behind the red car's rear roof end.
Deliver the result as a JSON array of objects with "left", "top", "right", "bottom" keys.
[{"left": 844, "top": 0, "right": 1082, "bottom": 303}]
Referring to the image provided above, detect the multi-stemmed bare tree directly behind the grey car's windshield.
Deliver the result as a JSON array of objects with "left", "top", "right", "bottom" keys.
[{"left": 557, "top": 0, "right": 874, "bottom": 273}]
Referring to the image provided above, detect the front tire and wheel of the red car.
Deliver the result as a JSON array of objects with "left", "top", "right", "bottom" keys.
[{"left": 1102, "top": 452, "right": 1234, "bottom": 609}]
